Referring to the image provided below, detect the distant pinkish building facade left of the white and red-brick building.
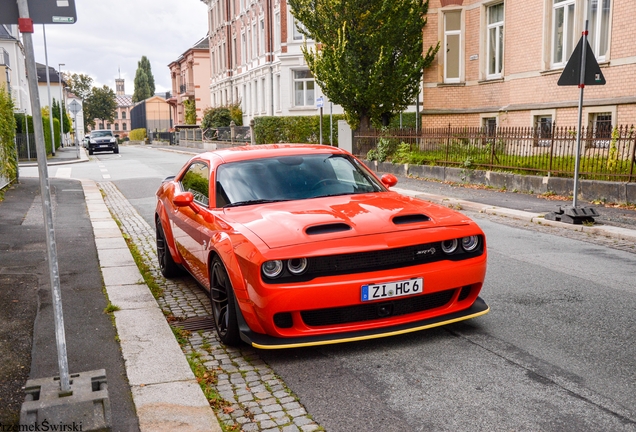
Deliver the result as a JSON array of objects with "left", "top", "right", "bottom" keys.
[{"left": 167, "top": 36, "right": 210, "bottom": 127}]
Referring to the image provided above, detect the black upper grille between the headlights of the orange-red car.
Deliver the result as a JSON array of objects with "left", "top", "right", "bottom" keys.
[{"left": 261, "top": 237, "right": 484, "bottom": 284}]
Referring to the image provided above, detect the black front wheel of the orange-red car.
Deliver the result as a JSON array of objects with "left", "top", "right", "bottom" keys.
[{"left": 210, "top": 256, "right": 241, "bottom": 346}]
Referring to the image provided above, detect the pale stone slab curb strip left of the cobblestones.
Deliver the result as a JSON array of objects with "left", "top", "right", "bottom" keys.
[{"left": 81, "top": 180, "right": 221, "bottom": 432}]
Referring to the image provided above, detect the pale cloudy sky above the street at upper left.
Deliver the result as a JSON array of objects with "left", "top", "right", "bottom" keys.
[{"left": 33, "top": 0, "right": 208, "bottom": 95}]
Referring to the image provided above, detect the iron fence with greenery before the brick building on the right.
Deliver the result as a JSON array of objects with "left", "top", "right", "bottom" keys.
[{"left": 353, "top": 125, "right": 636, "bottom": 181}]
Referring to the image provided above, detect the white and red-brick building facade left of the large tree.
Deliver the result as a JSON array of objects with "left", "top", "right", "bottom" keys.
[{"left": 203, "top": 0, "right": 342, "bottom": 124}]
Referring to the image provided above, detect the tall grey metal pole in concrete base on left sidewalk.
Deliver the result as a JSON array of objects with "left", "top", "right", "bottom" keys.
[{"left": 17, "top": 0, "right": 71, "bottom": 394}]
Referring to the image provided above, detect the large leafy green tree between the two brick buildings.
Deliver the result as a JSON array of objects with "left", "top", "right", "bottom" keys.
[{"left": 288, "top": 0, "right": 439, "bottom": 129}]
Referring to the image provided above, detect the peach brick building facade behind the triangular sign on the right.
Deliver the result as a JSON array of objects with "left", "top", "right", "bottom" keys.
[{"left": 422, "top": 0, "right": 636, "bottom": 131}]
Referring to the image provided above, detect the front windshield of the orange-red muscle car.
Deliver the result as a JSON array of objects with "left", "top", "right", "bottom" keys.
[{"left": 216, "top": 153, "right": 386, "bottom": 207}]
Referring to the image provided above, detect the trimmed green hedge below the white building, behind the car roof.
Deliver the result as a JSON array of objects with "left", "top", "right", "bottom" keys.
[{"left": 254, "top": 114, "right": 345, "bottom": 146}]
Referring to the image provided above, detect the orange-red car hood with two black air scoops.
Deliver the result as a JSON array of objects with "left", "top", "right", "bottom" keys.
[{"left": 225, "top": 192, "right": 471, "bottom": 248}]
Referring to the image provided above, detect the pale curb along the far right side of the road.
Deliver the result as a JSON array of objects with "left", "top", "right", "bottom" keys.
[{"left": 391, "top": 187, "right": 636, "bottom": 242}]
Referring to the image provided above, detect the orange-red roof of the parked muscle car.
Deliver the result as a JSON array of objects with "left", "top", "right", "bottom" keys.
[{"left": 198, "top": 144, "right": 349, "bottom": 162}]
